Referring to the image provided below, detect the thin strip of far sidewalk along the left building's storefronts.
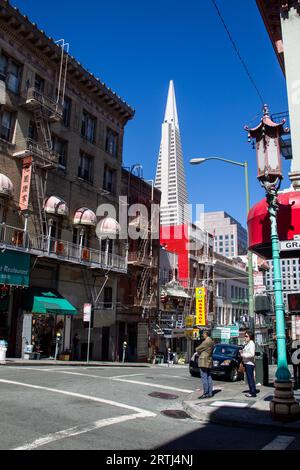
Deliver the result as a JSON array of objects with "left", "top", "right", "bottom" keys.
[{"left": 0, "top": 358, "right": 151, "bottom": 367}]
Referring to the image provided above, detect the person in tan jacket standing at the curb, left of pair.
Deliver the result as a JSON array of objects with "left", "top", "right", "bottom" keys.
[{"left": 196, "top": 331, "right": 214, "bottom": 399}]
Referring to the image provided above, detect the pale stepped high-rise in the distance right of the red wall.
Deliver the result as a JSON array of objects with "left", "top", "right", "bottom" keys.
[{"left": 204, "top": 211, "right": 247, "bottom": 258}]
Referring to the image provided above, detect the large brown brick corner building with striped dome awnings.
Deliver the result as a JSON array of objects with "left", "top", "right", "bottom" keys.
[{"left": 0, "top": 0, "right": 134, "bottom": 360}]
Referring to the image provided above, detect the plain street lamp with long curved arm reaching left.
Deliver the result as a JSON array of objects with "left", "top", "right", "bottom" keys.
[{"left": 190, "top": 157, "right": 255, "bottom": 333}]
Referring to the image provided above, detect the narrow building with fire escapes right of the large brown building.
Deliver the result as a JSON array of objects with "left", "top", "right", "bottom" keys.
[{"left": 117, "top": 168, "right": 160, "bottom": 362}]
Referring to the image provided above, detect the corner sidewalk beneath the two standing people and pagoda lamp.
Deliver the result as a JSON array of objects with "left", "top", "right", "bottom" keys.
[{"left": 183, "top": 382, "right": 300, "bottom": 432}]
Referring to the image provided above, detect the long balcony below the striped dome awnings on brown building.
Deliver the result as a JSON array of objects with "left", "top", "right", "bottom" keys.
[{"left": 0, "top": 224, "right": 127, "bottom": 273}]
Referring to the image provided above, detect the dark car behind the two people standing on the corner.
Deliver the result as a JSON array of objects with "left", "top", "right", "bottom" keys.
[{"left": 189, "top": 343, "right": 243, "bottom": 382}]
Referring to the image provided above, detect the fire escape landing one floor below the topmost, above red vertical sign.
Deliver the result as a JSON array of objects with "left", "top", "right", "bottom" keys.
[{"left": 13, "top": 138, "right": 59, "bottom": 168}]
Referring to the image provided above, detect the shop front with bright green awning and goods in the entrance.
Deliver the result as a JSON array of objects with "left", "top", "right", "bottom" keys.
[{"left": 22, "top": 287, "right": 78, "bottom": 360}]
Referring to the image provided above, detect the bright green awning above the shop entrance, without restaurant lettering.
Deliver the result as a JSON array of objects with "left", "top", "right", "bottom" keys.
[{"left": 22, "top": 287, "right": 78, "bottom": 315}]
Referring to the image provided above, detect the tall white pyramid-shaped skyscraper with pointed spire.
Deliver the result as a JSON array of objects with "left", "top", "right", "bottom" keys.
[{"left": 155, "top": 80, "right": 190, "bottom": 225}]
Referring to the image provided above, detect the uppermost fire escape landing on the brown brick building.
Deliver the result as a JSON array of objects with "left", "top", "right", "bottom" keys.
[{"left": 23, "top": 87, "right": 63, "bottom": 122}]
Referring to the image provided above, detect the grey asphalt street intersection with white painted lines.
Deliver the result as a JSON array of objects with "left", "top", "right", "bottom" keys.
[{"left": 0, "top": 365, "right": 300, "bottom": 452}]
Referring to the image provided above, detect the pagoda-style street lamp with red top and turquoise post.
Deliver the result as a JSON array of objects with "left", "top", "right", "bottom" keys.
[{"left": 245, "top": 105, "right": 300, "bottom": 421}]
